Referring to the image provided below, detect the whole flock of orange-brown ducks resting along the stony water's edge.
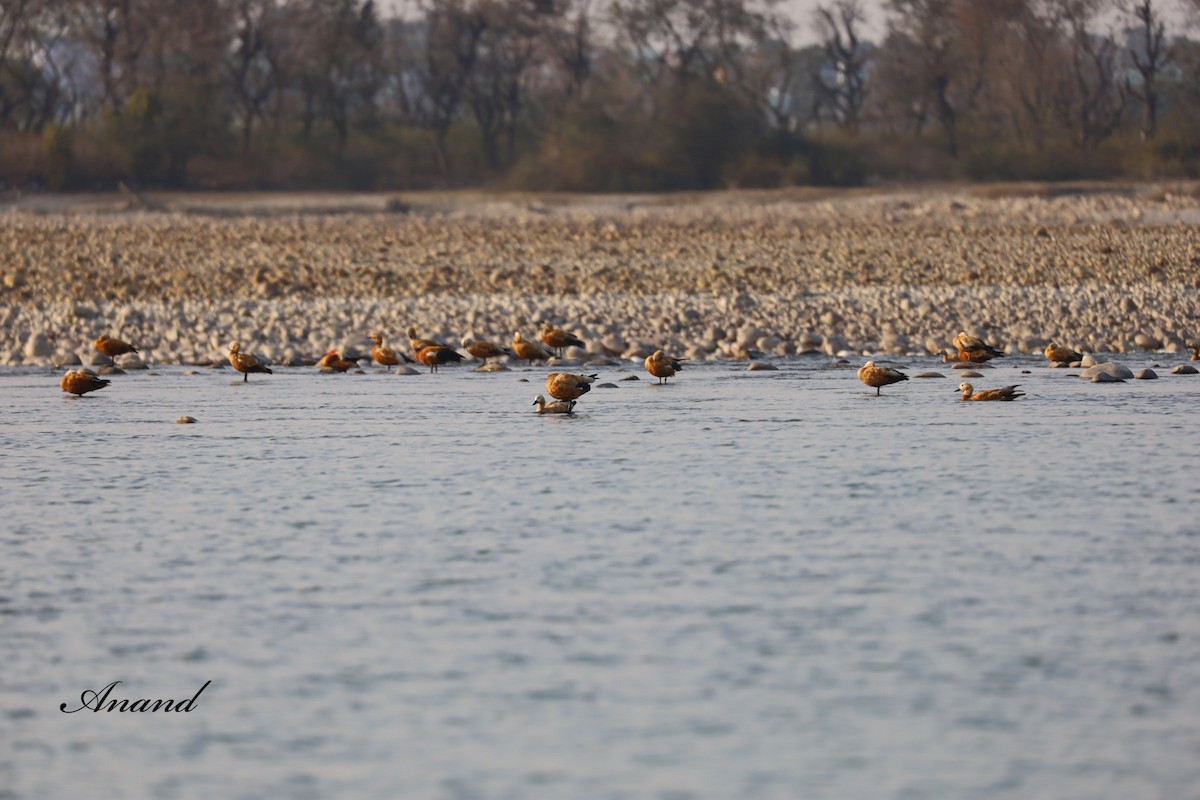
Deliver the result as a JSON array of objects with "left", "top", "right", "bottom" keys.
[{"left": 60, "top": 323, "right": 1200, "bottom": 414}]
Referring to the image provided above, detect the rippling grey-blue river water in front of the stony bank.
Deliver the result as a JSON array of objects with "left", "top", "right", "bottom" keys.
[{"left": 0, "top": 356, "right": 1200, "bottom": 800}]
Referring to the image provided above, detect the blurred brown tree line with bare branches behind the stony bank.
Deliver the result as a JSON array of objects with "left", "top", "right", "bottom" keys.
[{"left": 0, "top": 0, "right": 1200, "bottom": 191}]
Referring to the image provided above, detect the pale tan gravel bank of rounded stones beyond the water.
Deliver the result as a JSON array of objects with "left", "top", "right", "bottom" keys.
[{"left": 0, "top": 185, "right": 1200, "bottom": 365}]
